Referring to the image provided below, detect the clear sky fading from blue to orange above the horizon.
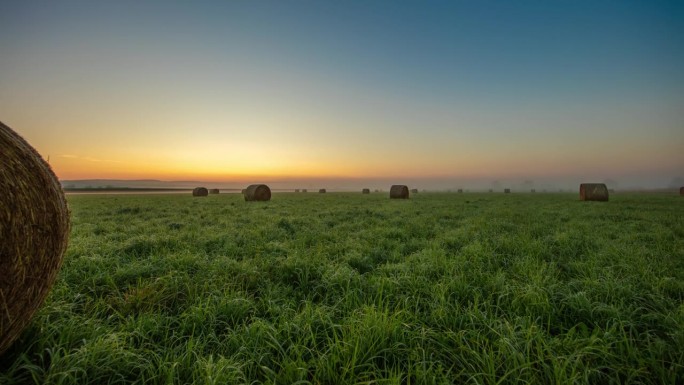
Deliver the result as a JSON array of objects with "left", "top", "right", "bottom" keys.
[{"left": 0, "top": 0, "right": 684, "bottom": 188}]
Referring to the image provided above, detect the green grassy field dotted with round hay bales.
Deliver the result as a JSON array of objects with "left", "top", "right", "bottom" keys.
[{"left": 0, "top": 193, "right": 684, "bottom": 385}]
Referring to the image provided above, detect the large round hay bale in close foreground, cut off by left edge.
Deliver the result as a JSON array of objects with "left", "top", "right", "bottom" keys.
[{"left": 0, "top": 122, "right": 69, "bottom": 355}]
